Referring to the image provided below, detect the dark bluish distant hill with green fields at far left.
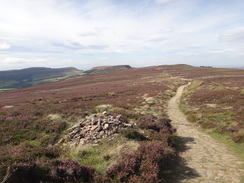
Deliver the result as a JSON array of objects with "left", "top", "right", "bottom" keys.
[{"left": 0, "top": 67, "right": 83, "bottom": 91}]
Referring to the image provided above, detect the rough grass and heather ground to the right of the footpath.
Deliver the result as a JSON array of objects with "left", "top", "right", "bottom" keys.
[{"left": 181, "top": 76, "right": 244, "bottom": 159}]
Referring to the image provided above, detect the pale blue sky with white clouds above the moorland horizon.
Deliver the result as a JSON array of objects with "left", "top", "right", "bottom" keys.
[{"left": 0, "top": 0, "right": 244, "bottom": 70}]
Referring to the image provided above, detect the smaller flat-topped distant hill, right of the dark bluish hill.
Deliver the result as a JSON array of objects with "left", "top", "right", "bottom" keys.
[{"left": 84, "top": 65, "right": 132, "bottom": 75}]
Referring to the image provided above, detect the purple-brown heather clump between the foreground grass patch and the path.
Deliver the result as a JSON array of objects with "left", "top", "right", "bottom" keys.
[{"left": 107, "top": 142, "right": 173, "bottom": 183}]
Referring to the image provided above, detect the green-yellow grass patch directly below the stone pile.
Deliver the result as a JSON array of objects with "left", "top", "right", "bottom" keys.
[{"left": 65, "top": 135, "right": 139, "bottom": 173}]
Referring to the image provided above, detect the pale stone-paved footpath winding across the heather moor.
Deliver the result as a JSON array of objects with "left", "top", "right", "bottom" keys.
[{"left": 168, "top": 85, "right": 244, "bottom": 183}]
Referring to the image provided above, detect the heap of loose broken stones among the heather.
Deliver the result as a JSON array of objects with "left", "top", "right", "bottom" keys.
[{"left": 58, "top": 112, "right": 133, "bottom": 146}]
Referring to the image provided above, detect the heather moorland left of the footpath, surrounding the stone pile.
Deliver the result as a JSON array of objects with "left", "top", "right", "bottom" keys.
[{"left": 0, "top": 67, "right": 181, "bottom": 182}]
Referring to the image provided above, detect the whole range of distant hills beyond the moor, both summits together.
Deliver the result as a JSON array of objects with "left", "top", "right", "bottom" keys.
[{"left": 0, "top": 65, "right": 131, "bottom": 92}]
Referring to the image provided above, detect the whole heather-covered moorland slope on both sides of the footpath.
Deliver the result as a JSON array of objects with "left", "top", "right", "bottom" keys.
[{"left": 0, "top": 65, "right": 244, "bottom": 182}]
